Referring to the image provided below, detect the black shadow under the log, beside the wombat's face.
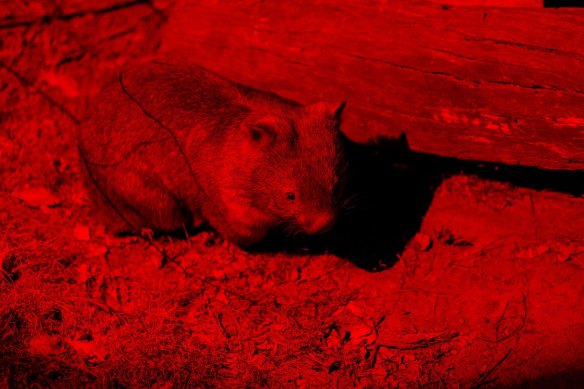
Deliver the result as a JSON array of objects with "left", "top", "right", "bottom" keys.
[{"left": 254, "top": 135, "right": 584, "bottom": 271}]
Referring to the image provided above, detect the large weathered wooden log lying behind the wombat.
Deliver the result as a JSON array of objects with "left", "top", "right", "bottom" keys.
[{"left": 162, "top": 0, "right": 584, "bottom": 170}]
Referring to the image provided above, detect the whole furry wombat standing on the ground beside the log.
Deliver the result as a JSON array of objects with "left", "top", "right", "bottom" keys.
[{"left": 79, "top": 62, "right": 345, "bottom": 245}]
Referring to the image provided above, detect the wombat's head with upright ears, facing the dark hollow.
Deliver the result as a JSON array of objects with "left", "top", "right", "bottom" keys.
[{"left": 244, "top": 102, "right": 345, "bottom": 234}]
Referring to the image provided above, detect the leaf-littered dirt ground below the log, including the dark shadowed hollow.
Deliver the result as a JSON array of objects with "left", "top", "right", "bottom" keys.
[{"left": 0, "top": 1, "right": 584, "bottom": 388}]
